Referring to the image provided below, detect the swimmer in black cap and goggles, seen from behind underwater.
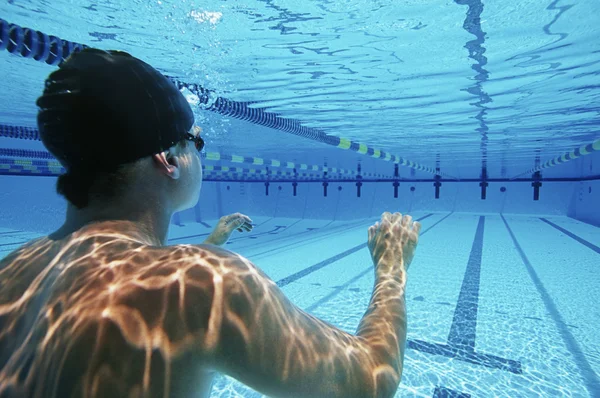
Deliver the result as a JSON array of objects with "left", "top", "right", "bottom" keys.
[{"left": 0, "top": 49, "right": 421, "bottom": 398}]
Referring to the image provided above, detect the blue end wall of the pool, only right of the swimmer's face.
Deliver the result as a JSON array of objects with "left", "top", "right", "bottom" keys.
[{"left": 190, "top": 182, "right": 578, "bottom": 220}]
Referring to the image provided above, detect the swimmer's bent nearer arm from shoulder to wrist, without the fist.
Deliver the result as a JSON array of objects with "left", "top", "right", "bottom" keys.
[{"left": 202, "top": 246, "right": 406, "bottom": 398}]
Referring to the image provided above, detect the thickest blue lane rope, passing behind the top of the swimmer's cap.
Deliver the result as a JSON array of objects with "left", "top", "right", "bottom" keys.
[{"left": 0, "top": 19, "right": 450, "bottom": 180}]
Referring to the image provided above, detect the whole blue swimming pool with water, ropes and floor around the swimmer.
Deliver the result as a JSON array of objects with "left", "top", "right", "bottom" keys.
[{"left": 0, "top": 0, "right": 600, "bottom": 397}]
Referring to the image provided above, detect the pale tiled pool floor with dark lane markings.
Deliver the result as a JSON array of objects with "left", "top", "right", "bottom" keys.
[{"left": 0, "top": 212, "right": 600, "bottom": 397}]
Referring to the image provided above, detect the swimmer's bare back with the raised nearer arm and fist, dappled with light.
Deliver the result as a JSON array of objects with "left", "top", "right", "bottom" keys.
[{"left": 0, "top": 213, "right": 420, "bottom": 398}]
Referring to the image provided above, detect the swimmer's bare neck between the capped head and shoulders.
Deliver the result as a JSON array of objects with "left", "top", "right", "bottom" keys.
[{"left": 49, "top": 200, "right": 173, "bottom": 246}]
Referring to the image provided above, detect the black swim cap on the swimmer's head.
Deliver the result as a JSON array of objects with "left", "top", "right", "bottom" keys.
[{"left": 37, "top": 49, "right": 194, "bottom": 171}]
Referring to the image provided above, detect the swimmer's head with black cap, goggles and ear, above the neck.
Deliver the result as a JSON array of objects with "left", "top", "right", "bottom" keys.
[{"left": 37, "top": 49, "right": 201, "bottom": 210}]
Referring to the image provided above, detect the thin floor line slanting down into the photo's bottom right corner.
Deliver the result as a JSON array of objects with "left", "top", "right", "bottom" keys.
[{"left": 501, "top": 215, "right": 600, "bottom": 397}]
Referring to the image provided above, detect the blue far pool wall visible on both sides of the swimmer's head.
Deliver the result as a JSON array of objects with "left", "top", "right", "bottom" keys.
[{"left": 0, "top": 176, "right": 584, "bottom": 232}]
